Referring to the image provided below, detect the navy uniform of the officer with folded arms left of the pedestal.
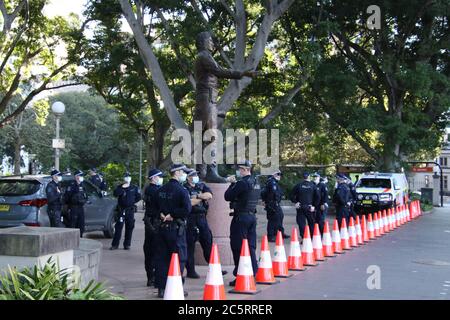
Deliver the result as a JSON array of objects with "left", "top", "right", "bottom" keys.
[{"left": 184, "top": 182, "right": 212, "bottom": 275}]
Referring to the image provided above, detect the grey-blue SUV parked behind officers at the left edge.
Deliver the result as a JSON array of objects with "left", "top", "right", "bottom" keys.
[{"left": 0, "top": 175, "right": 117, "bottom": 238}]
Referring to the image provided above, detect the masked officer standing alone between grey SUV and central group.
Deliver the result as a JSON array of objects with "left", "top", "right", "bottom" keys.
[{"left": 110, "top": 172, "right": 141, "bottom": 250}]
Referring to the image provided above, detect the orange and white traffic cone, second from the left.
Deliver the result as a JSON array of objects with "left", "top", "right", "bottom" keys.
[{"left": 203, "top": 243, "right": 226, "bottom": 300}]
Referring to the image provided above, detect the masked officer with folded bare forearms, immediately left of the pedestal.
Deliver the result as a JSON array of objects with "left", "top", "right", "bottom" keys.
[{"left": 184, "top": 170, "right": 221, "bottom": 279}]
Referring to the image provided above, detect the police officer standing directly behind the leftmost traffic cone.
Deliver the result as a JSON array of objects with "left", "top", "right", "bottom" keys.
[{"left": 155, "top": 164, "right": 192, "bottom": 298}]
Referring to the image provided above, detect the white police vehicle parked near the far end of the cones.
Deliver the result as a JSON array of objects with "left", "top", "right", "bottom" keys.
[{"left": 355, "top": 172, "right": 409, "bottom": 213}]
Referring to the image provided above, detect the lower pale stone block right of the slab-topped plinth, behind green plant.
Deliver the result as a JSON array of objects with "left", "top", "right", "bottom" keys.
[{"left": 73, "top": 238, "right": 102, "bottom": 288}]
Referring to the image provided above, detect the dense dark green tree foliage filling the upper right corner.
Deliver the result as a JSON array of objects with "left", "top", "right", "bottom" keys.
[{"left": 283, "top": 0, "right": 450, "bottom": 169}]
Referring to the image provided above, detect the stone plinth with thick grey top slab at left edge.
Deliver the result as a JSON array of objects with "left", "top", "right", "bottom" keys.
[{"left": 0, "top": 227, "right": 80, "bottom": 271}]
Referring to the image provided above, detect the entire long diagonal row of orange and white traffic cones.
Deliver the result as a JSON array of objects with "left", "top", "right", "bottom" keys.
[{"left": 164, "top": 200, "right": 422, "bottom": 300}]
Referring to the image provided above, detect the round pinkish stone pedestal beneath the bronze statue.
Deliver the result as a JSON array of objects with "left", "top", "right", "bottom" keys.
[{"left": 195, "top": 183, "right": 234, "bottom": 265}]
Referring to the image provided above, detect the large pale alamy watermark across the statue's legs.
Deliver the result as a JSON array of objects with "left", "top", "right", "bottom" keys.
[{"left": 171, "top": 121, "right": 280, "bottom": 175}]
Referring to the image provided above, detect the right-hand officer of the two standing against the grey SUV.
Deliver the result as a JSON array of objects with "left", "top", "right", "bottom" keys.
[{"left": 65, "top": 170, "right": 88, "bottom": 237}]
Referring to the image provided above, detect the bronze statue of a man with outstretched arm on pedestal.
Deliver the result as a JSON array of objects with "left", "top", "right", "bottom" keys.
[{"left": 194, "top": 32, "right": 258, "bottom": 183}]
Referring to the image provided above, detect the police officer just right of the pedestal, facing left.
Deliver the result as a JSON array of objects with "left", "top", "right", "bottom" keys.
[{"left": 225, "top": 160, "right": 261, "bottom": 286}]
